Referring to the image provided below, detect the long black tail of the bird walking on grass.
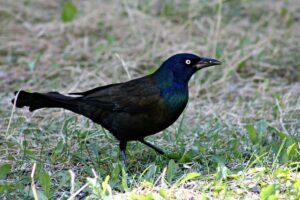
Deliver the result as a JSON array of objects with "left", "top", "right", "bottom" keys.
[{"left": 12, "top": 90, "right": 78, "bottom": 112}]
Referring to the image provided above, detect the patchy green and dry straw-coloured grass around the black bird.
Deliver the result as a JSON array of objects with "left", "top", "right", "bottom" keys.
[{"left": 0, "top": 0, "right": 300, "bottom": 199}]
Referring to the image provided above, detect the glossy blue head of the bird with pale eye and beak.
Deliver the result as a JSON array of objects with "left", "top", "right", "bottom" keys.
[{"left": 157, "top": 53, "right": 221, "bottom": 83}]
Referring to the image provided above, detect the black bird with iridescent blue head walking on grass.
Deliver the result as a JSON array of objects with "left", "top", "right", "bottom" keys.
[{"left": 12, "top": 53, "right": 221, "bottom": 162}]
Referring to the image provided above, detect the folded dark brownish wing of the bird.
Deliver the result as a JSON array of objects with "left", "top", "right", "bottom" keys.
[{"left": 73, "top": 76, "right": 161, "bottom": 113}]
